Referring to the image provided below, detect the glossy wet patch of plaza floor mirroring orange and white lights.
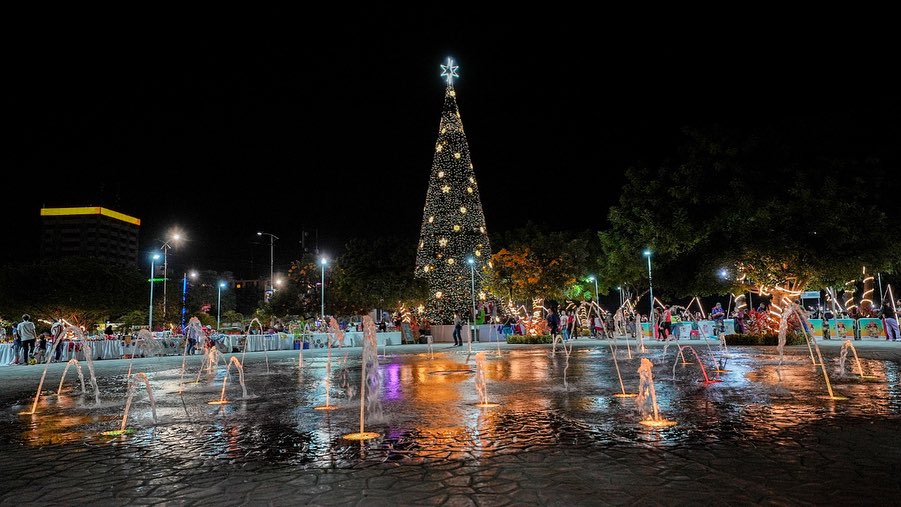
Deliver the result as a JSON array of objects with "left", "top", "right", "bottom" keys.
[{"left": 0, "top": 347, "right": 901, "bottom": 503}]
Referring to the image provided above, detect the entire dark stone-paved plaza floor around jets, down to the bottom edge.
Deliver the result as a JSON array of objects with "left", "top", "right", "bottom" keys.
[{"left": 0, "top": 340, "right": 901, "bottom": 505}]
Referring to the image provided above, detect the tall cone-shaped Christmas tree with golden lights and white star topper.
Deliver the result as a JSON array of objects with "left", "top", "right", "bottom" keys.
[{"left": 416, "top": 58, "right": 491, "bottom": 323}]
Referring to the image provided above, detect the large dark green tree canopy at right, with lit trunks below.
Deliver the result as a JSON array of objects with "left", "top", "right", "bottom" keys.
[{"left": 600, "top": 111, "right": 901, "bottom": 297}]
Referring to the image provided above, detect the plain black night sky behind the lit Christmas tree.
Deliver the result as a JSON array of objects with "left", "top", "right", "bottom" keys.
[{"left": 2, "top": 8, "right": 898, "bottom": 277}]
